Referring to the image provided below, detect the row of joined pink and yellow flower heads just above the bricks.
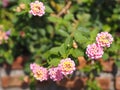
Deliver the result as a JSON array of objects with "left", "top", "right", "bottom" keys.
[{"left": 30, "top": 58, "right": 75, "bottom": 81}]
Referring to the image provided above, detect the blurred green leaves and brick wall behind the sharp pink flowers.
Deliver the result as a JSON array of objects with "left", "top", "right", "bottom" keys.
[{"left": 0, "top": 0, "right": 120, "bottom": 90}]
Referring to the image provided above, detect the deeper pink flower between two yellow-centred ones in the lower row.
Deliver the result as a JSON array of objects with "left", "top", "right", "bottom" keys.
[{"left": 49, "top": 67, "right": 63, "bottom": 81}]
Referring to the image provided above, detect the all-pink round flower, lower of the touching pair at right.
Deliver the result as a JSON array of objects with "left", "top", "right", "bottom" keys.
[{"left": 86, "top": 43, "right": 104, "bottom": 59}]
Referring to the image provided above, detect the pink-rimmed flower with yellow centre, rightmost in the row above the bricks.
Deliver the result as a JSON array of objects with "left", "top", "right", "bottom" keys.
[{"left": 58, "top": 58, "right": 75, "bottom": 75}]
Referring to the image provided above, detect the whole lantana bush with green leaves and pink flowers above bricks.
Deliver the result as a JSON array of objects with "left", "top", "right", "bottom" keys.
[{"left": 0, "top": 0, "right": 120, "bottom": 90}]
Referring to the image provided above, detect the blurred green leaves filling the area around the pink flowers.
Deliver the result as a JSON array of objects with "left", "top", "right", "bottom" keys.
[{"left": 0, "top": 0, "right": 120, "bottom": 89}]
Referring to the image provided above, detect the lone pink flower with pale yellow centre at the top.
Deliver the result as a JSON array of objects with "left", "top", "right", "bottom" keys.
[{"left": 30, "top": 1, "right": 45, "bottom": 16}]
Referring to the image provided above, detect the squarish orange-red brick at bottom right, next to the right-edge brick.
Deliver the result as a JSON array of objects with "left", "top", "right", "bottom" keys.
[{"left": 96, "top": 77, "right": 111, "bottom": 90}]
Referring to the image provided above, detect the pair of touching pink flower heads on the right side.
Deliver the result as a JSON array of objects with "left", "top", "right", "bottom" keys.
[{"left": 86, "top": 32, "right": 113, "bottom": 59}]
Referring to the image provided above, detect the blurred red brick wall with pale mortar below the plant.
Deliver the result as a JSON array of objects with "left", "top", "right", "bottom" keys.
[{"left": 0, "top": 57, "right": 120, "bottom": 90}]
